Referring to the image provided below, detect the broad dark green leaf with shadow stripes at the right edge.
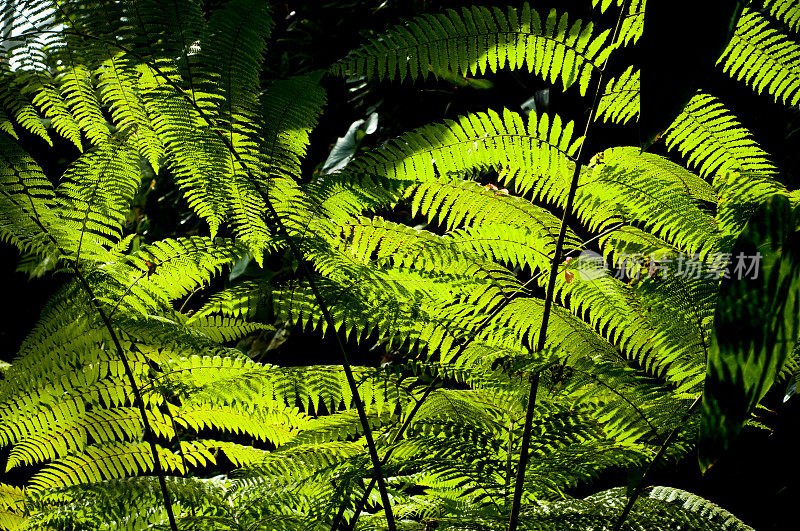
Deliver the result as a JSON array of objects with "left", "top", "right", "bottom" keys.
[{"left": 699, "top": 195, "right": 800, "bottom": 470}]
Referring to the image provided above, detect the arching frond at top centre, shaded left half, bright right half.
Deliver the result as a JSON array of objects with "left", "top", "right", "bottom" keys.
[{"left": 333, "top": 3, "right": 609, "bottom": 94}]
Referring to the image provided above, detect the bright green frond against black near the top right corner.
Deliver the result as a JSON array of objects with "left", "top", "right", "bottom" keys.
[{"left": 718, "top": 8, "right": 800, "bottom": 107}]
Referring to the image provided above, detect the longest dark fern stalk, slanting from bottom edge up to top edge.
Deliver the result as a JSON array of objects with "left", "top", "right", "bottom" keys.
[{"left": 508, "top": 4, "right": 628, "bottom": 531}]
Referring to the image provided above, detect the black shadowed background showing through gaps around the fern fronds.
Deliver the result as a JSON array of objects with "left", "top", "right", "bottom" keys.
[{"left": 0, "top": 0, "right": 800, "bottom": 530}]
